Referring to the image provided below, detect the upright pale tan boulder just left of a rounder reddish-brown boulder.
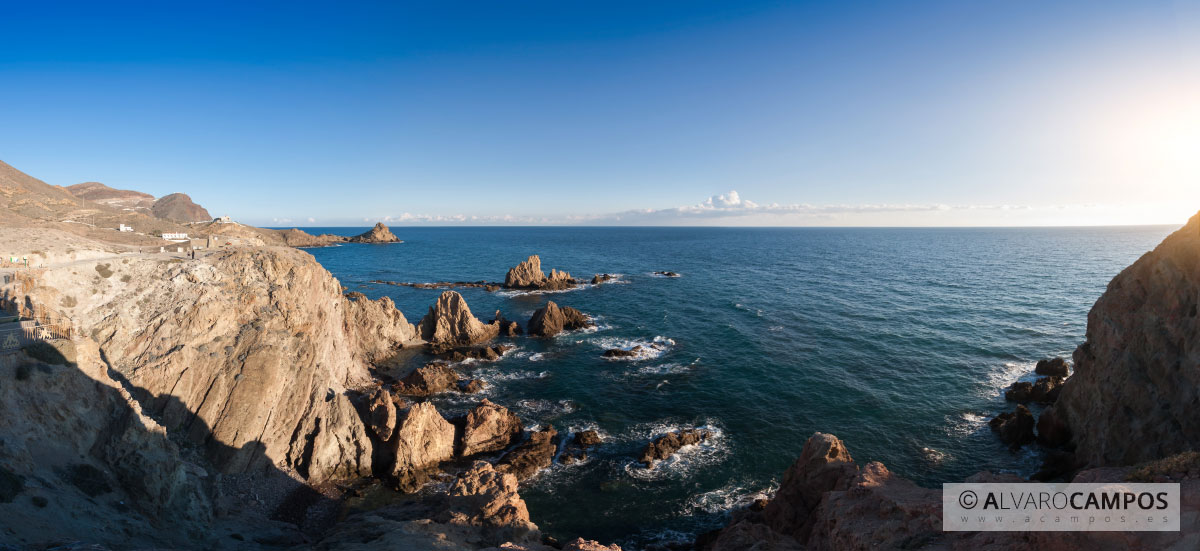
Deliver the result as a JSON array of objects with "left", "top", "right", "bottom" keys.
[{"left": 390, "top": 402, "right": 454, "bottom": 492}]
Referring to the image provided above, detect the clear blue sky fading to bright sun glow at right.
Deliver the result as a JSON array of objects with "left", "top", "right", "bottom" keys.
[{"left": 0, "top": 1, "right": 1200, "bottom": 226}]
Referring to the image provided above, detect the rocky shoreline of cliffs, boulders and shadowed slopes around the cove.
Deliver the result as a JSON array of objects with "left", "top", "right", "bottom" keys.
[{"left": 0, "top": 205, "right": 1200, "bottom": 551}]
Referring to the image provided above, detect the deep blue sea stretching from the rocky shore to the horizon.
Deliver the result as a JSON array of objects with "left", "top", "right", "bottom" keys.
[{"left": 295, "top": 227, "right": 1175, "bottom": 549}]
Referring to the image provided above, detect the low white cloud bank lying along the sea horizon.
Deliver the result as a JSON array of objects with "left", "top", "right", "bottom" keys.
[{"left": 260, "top": 190, "right": 1200, "bottom": 227}]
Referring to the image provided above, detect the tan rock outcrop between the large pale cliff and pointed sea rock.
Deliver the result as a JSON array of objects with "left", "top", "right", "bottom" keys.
[{"left": 346, "top": 293, "right": 425, "bottom": 363}]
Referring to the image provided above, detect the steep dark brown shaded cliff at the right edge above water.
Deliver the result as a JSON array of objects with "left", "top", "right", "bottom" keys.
[{"left": 1055, "top": 215, "right": 1200, "bottom": 466}]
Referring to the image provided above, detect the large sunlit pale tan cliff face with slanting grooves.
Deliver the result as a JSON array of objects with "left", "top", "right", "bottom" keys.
[{"left": 30, "top": 247, "right": 372, "bottom": 481}]
